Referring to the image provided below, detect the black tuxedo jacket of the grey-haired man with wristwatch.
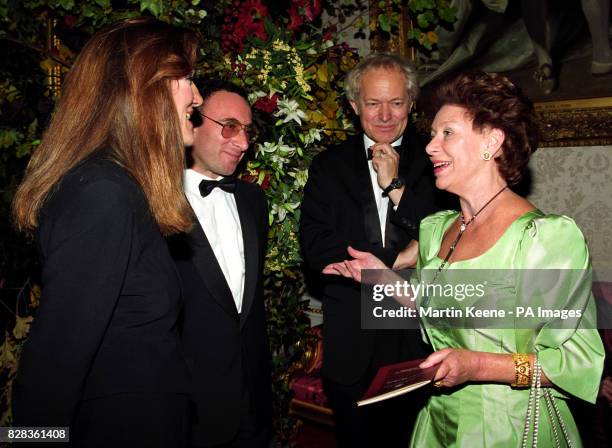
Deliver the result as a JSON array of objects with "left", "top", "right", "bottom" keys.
[{"left": 300, "top": 127, "right": 436, "bottom": 384}]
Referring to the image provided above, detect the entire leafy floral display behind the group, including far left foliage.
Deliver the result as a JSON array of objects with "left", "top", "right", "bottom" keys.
[{"left": 0, "top": 0, "right": 452, "bottom": 445}]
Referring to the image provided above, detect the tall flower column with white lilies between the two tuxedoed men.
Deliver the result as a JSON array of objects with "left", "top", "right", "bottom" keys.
[{"left": 201, "top": 0, "right": 357, "bottom": 443}]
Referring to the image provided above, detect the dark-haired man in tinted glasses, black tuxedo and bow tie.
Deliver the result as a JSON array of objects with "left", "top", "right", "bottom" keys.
[{"left": 172, "top": 81, "right": 271, "bottom": 447}]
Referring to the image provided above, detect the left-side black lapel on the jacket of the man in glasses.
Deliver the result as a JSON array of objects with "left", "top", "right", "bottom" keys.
[{"left": 189, "top": 222, "right": 238, "bottom": 319}]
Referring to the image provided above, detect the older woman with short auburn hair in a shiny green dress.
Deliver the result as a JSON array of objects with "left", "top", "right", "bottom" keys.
[{"left": 324, "top": 73, "right": 604, "bottom": 447}]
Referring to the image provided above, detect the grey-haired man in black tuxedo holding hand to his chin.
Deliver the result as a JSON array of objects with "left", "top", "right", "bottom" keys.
[{"left": 300, "top": 54, "right": 435, "bottom": 447}]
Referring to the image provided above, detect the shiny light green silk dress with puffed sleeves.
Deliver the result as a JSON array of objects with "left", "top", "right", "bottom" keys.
[{"left": 411, "top": 210, "right": 604, "bottom": 448}]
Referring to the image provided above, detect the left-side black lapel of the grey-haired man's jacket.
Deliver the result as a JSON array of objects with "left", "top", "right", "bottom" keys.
[{"left": 355, "top": 136, "right": 382, "bottom": 246}]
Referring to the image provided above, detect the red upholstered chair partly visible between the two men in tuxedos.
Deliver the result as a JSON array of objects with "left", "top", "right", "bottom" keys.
[{"left": 289, "top": 326, "right": 333, "bottom": 426}]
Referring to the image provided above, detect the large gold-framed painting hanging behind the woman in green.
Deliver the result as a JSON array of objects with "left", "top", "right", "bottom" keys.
[{"left": 370, "top": 0, "right": 612, "bottom": 147}]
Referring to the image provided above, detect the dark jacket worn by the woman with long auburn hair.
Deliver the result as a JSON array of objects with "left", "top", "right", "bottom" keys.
[{"left": 13, "top": 153, "right": 190, "bottom": 431}]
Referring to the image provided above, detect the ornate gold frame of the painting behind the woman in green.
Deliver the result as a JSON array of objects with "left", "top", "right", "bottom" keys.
[{"left": 370, "top": 0, "right": 612, "bottom": 147}]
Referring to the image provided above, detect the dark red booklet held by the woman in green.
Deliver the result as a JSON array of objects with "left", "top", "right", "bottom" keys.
[{"left": 357, "top": 359, "right": 440, "bottom": 406}]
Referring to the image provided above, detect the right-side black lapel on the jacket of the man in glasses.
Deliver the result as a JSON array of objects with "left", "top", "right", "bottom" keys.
[{"left": 234, "top": 181, "right": 261, "bottom": 327}]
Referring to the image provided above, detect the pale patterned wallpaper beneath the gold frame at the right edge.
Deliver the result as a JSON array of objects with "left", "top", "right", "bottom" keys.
[{"left": 528, "top": 146, "right": 612, "bottom": 281}]
